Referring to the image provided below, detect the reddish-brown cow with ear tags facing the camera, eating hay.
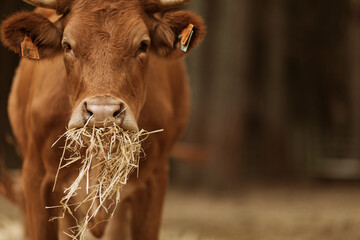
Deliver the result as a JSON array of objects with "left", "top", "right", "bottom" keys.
[{"left": 1, "top": 0, "right": 205, "bottom": 240}]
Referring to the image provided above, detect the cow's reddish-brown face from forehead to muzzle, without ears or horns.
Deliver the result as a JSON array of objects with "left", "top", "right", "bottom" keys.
[{"left": 61, "top": 1, "right": 151, "bottom": 131}]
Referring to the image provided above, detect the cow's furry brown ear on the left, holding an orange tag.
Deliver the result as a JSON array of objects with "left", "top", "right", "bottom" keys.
[{"left": 1, "top": 12, "right": 62, "bottom": 59}]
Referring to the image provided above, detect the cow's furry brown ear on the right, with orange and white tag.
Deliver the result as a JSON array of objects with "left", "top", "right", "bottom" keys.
[{"left": 151, "top": 11, "right": 206, "bottom": 58}]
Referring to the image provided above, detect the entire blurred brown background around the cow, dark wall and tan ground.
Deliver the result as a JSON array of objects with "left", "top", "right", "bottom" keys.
[{"left": 0, "top": 0, "right": 360, "bottom": 240}]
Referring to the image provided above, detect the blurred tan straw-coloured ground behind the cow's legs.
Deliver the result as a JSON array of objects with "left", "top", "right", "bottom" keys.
[{"left": 0, "top": 183, "right": 360, "bottom": 240}]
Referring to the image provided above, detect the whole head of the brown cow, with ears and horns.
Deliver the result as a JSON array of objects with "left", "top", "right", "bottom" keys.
[{"left": 2, "top": 0, "right": 205, "bottom": 130}]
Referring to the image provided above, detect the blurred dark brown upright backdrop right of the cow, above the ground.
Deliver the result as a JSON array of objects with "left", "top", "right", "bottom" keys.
[{"left": 173, "top": 0, "right": 360, "bottom": 187}]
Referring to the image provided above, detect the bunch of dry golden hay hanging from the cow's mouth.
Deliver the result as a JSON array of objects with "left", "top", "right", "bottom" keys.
[{"left": 48, "top": 120, "right": 163, "bottom": 240}]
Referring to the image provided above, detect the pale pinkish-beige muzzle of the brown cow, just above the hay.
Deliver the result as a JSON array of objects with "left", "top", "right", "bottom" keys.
[{"left": 68, "top": 95, "right": 139, "bottom": 132}]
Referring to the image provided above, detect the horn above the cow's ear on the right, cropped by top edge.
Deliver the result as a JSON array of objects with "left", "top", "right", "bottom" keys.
[{"left": 142, "top": 0, "right": 192, "bottom": 13}]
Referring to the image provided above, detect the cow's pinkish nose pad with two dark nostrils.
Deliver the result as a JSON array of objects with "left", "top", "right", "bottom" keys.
[{"left": 84, "top": 101, "right": 126, "bottom": 124}]
